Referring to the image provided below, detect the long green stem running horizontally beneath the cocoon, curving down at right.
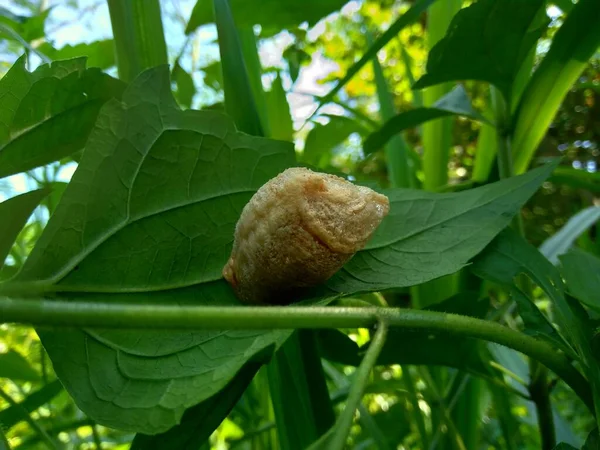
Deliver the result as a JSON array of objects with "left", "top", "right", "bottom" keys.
[{"left": 0, "top": 297, "right": 594, "bottom": 411}]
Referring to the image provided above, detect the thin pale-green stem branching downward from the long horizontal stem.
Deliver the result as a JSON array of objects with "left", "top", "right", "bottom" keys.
[{"left": 328, "top": 320, "right": 388, "bottom": 450}]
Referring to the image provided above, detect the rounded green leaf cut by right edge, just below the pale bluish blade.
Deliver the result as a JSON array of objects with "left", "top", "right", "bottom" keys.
[{"left": 559, "top": 249, "right": 600, "bottom": 313}]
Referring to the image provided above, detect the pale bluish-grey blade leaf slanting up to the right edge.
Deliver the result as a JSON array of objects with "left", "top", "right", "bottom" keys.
[{"left": 540, "top": 206, "right": 600, "bottom": 265}]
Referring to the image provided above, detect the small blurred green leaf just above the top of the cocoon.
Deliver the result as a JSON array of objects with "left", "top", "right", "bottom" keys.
[{"left": 302, "top": 116, "right": 365, "bottom": 165}]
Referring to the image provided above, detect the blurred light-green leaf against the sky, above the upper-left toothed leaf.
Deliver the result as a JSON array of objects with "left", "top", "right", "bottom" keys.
[{"left": 37, "top": 39, "right": 115, "bottom": 70}]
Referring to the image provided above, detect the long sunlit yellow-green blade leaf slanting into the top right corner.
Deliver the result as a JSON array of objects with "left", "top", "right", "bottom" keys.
[{"left": 512, "top": 0, "right": 600, "bottom": 173}]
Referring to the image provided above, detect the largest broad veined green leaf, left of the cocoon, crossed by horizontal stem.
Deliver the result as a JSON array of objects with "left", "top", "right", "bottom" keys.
[{"left": 10, "top": 67, "right": 294, "bottom": 434}]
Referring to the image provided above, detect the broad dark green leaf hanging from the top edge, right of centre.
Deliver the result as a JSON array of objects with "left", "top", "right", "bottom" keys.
[{"left": 414, "top": 0, "right": 545, "bottom": 100}]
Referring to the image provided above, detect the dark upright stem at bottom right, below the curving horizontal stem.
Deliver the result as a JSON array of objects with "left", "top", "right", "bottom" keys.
[{"left": 529, "top": 359, "right": 556, "bottom": 450}]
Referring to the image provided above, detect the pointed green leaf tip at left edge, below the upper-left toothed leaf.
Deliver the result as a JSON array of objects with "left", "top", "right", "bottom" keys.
[{"left": 0, "top": 189, "right": 48, "bottom": 269}]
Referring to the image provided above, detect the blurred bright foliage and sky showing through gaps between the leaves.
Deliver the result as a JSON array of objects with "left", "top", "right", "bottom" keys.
[{"left": 0, "top": 0, "right": 600, "bottom": 449}]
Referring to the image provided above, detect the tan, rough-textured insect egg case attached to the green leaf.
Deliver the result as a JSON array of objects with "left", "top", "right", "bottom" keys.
[{"left": 223, "top": 168, "right": 389, "bottom": 304}]
